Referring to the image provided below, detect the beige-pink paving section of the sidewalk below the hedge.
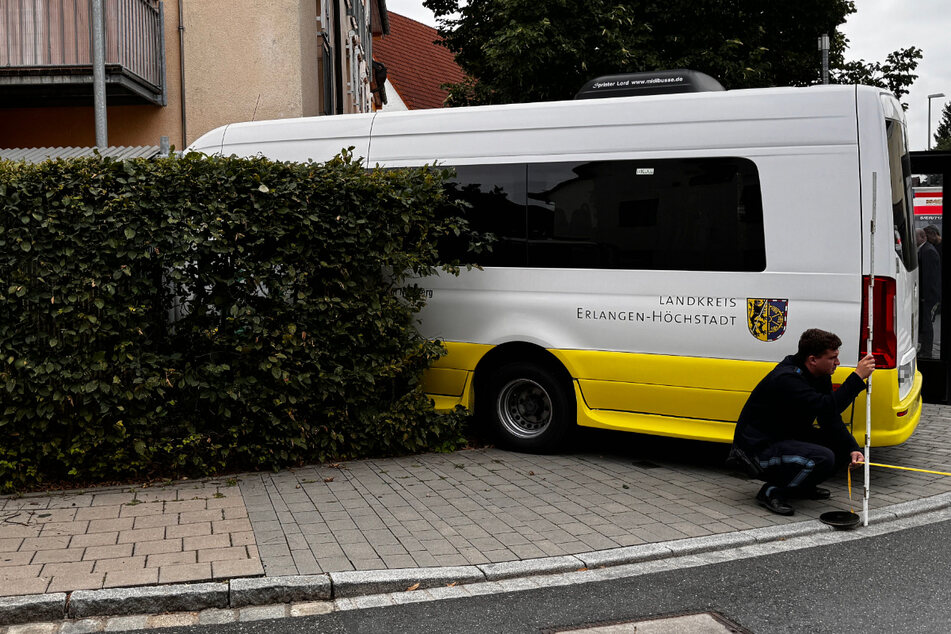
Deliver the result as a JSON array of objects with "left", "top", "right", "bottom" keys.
[{"left": 0, "top": 480, "right": 264, "bottom": 596}]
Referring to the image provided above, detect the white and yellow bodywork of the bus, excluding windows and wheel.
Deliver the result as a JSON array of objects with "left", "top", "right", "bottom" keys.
[{"left": 190, "top": 86, "right": 921, "bottom": 445}]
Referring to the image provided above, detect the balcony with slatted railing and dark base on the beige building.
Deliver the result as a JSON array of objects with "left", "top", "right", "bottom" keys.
[{"left": 0, "top": 0, "right": 165, "bottom": 105}]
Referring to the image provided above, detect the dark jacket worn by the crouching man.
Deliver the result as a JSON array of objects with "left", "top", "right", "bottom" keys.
[{"left": 733, "top": 355, "right": 865, "bottom": 456}]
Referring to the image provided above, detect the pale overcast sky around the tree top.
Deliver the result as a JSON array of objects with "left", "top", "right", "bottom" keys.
[{"left": 386, "top": 0, "right": 951, "bottom": 150}]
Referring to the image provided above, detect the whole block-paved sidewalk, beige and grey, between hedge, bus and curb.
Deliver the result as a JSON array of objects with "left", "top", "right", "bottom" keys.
[{"left": 0, "top": 405, "right": 951, "bottom": 625}]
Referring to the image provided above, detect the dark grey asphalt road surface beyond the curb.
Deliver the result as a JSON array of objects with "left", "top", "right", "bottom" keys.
[{"left": 147, "top": 520, "right": 951, "bottom": 634}]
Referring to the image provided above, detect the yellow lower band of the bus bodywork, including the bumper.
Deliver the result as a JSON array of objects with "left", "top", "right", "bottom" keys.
[{"left": 424, "top": 342, "right": 922, "bottom": 447}]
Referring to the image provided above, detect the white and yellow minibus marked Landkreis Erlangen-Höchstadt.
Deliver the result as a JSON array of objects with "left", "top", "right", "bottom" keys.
[{"left": 190, "top": 73, "right": 921, "bottom": 451}]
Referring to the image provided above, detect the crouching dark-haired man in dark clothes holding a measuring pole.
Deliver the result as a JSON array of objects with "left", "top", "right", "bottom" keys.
[{"left": 731, "top": 328, "right": 875, "bottom": 515}]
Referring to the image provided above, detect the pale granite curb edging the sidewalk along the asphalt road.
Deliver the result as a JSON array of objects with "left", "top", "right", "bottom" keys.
[{"left": 7, "top": 493, "right": 951, "bottom": 626}]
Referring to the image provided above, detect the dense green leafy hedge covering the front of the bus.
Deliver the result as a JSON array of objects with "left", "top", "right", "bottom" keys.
[{"left": 0, "top": 154, "right": 476, "bottom": 490}]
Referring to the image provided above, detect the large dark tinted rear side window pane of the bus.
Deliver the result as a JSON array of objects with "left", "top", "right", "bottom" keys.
[{"left": 528, "top": 158, "right": 766, "bottom": 271}]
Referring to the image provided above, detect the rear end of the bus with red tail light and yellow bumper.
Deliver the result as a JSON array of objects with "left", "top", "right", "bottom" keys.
[{"left": 856, "top": 87, "right": 922, "bottom": 446}]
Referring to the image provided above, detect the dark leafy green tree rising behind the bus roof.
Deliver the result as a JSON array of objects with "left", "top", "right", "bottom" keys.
[{"left": 423, "top": 0, "right": 920, "bottom": 105}]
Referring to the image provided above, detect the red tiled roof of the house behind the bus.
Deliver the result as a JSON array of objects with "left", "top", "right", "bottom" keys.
[{"left": 373, "top": 11, "right": 465, "bottom": 110}]
